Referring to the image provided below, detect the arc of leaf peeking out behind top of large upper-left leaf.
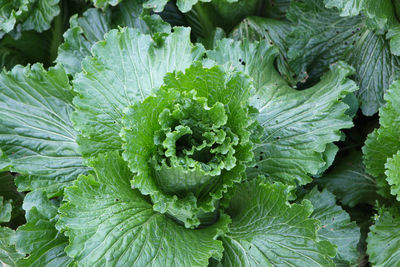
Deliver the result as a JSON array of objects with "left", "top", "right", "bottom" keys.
[{"left": 56, "top": 0, "right": 170, "bottom": 74}]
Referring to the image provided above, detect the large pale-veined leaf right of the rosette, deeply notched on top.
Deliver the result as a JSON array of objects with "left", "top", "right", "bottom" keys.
[{"left": 207, "top": 40, "right": 357, "bottom": 184}]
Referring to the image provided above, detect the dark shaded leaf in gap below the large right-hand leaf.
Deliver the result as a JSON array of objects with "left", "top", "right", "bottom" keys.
[{"left": 315, "top": 152, "right": 378, "bottom": 207}]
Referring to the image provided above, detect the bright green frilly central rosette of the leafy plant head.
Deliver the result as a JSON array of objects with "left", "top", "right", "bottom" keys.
[{"left": 121, "top": 63, "right": 256, "bottom": 228}]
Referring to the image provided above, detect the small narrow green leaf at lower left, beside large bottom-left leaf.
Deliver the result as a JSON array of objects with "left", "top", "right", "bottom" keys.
[{"left": 16, "top": 190, "right": 73, "bottom": 267}]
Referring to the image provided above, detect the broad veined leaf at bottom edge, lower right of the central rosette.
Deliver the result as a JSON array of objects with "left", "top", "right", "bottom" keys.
[{"left": 221, "top": 179, "right": 336, "bottom": 266}]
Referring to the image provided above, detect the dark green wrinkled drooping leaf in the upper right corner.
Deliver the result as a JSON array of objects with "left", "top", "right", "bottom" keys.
[{"left": 287, "top": 0, "right": 400, "bottom": 116}]
